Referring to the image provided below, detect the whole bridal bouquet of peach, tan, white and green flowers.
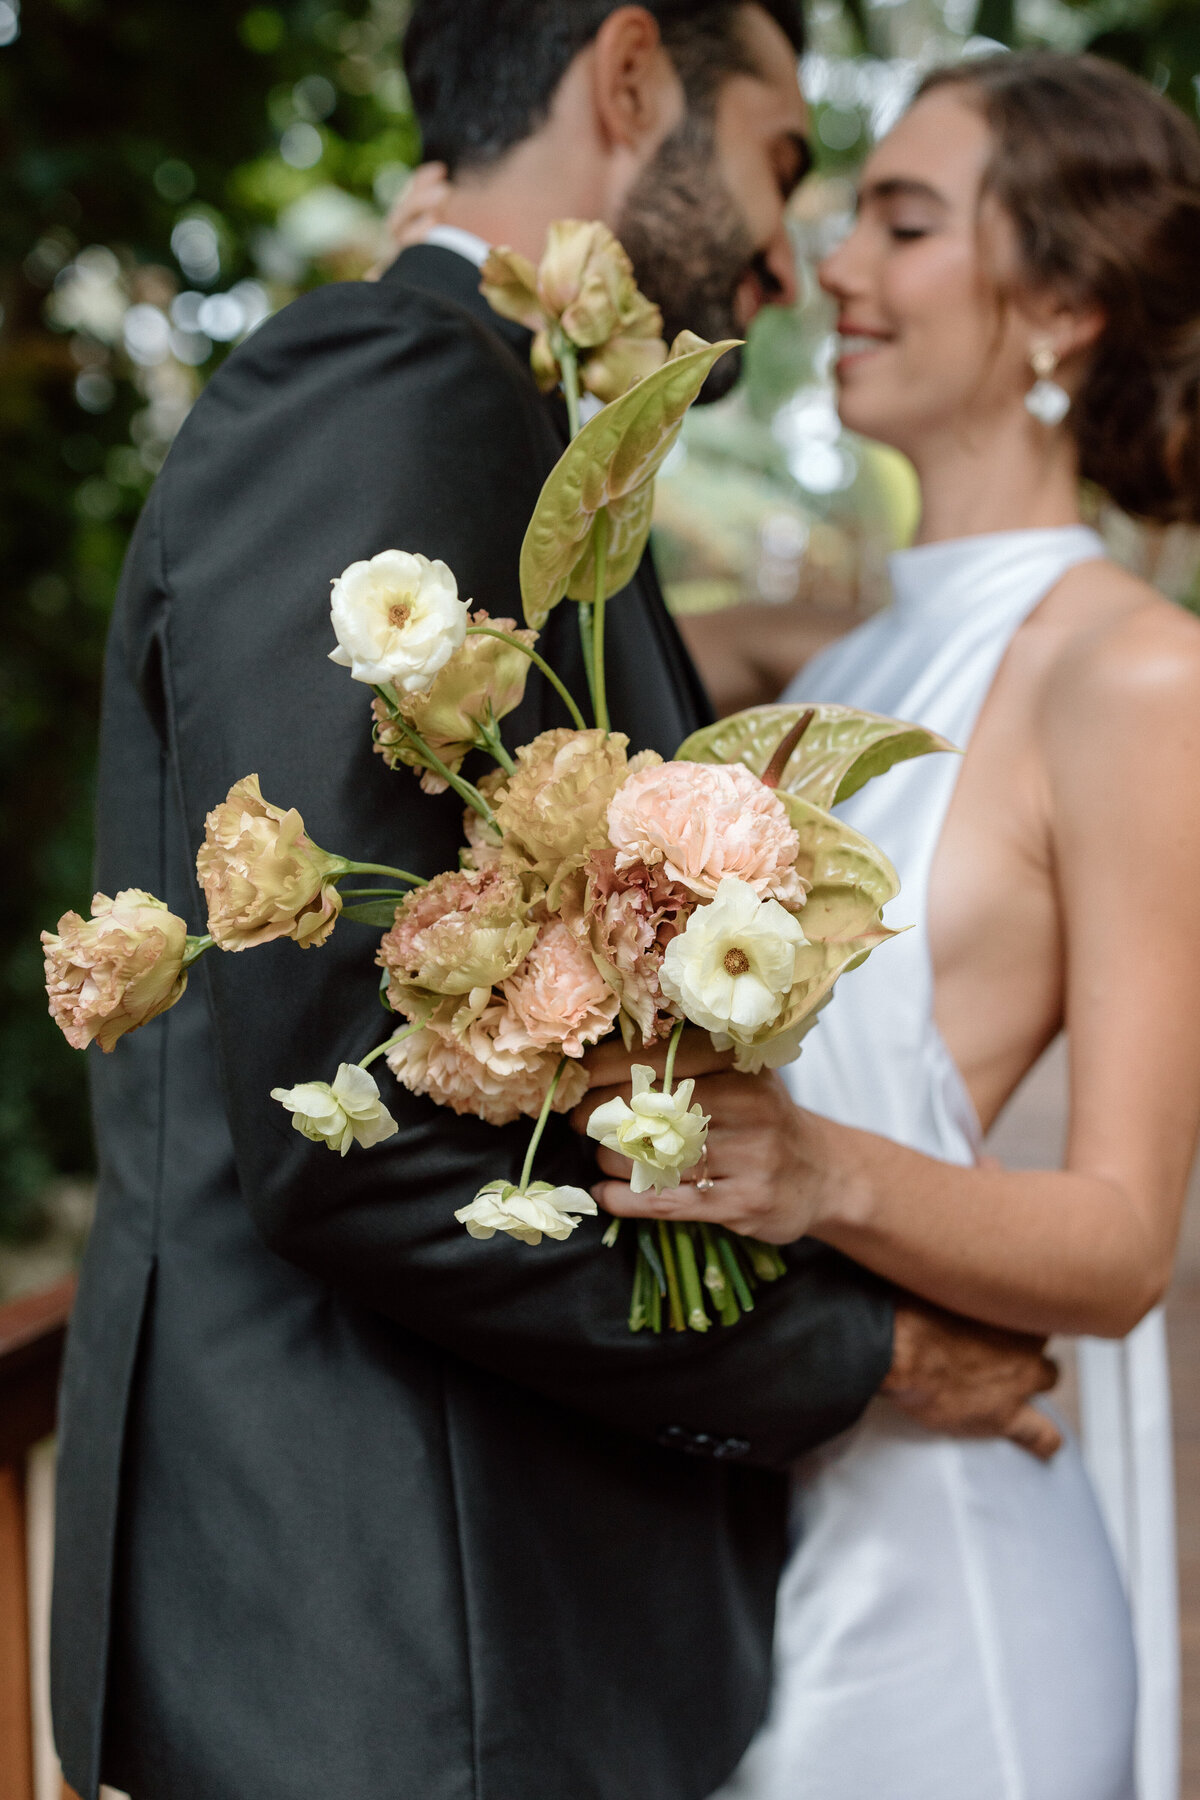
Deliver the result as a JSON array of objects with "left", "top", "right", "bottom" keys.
[{"left": 43, "top": 221, "right": 945, "bottom": 1330}]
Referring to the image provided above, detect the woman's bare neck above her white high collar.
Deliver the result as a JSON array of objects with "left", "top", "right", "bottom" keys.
[{"left": 909, "top": 409, "right": 1079, "bottom": 544}]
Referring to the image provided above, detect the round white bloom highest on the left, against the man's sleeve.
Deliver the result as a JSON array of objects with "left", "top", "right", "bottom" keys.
[{"left": 329, "top": 551, "right": 468, "bottom": 693}]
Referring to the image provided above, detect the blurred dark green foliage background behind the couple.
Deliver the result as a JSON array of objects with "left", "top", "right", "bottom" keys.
[{"left": 0, "top": 0, "right": 1200, "bottom": 1238}]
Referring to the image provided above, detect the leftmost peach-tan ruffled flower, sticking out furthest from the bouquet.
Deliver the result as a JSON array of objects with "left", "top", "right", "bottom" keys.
[{"left": 41, "top": 887, "right": 187, "bottom": 1049}]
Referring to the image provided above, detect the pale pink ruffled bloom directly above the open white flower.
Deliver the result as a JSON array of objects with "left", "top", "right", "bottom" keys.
[{"left": 608, "top": 763, "right": 808, "bottom": 907}]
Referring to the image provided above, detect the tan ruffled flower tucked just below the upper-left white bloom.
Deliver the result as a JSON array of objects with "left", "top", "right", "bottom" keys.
[{"left": 371, "top": 608, "right": 538, "bottom": 794}]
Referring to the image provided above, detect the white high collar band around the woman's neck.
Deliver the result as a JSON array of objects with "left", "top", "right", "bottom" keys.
[{"left": 887, "top": 526, "right": 1108, "bottom": 617}]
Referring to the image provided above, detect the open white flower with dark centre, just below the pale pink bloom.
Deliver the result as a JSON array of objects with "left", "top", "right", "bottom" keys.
[{"left": 658, "top": 875, "right": 808, "bottom": 1044}]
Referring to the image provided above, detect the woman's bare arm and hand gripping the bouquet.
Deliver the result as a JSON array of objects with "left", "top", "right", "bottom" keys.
[{"left": 588, "top": 605, "right": 1200, "bottom": 1336}]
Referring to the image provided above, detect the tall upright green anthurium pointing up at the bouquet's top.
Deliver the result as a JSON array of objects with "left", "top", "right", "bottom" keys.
[{"left": 520, "top": 338, "right": 738, "bottom": 630}]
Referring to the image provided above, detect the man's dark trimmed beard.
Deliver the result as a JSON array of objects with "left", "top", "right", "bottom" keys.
[{"left": 617, "top": 115, "right": 754, "bottom": 400}]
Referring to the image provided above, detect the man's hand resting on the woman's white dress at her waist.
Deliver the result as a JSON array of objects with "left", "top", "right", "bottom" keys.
[{"left": 880, "top": 1296, "right": 1063, "bottom": 1462}]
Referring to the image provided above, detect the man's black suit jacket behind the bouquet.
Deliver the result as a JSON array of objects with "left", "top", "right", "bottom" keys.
[{"left": 52, "top": 247, "right": 891, "bottom": 1800}]
